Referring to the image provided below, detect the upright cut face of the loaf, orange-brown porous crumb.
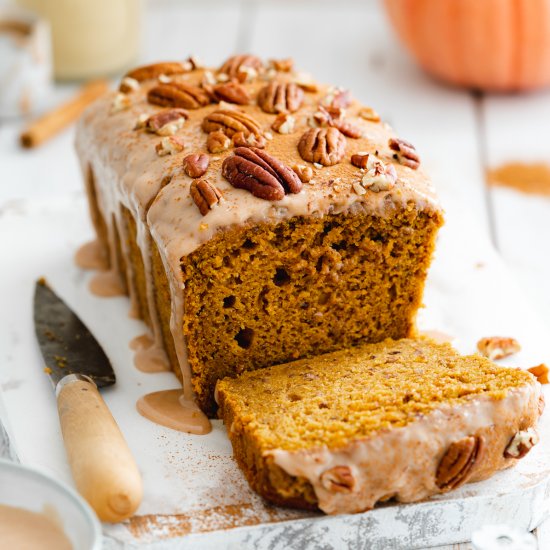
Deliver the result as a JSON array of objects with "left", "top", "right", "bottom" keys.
[{"left": 182, "top": 210, "right": 440, "bottom": 412}]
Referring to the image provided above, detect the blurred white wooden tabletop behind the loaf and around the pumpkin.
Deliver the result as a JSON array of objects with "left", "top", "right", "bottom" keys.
[{"left": 0, "top": 0, "right": 550, "bottom": 549}]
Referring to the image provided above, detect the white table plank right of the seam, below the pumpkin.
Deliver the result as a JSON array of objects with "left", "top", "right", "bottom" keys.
[{"left": 483, "top": 92, "right": 550, "bottom": 327}]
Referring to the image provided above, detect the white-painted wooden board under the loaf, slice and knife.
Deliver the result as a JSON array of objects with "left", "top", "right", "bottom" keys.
[{"left": 0, "top": 192, "right": 550, "bottom": 549}]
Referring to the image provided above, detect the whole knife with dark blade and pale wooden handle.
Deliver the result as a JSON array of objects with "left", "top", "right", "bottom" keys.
[{"left": 34, "top": 279, "right": 143, "bottom": 522}]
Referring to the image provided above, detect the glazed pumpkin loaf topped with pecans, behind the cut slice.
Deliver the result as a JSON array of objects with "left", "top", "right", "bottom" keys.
[{"left": 77, "top": 55, "right": 442, "bottom": 415}]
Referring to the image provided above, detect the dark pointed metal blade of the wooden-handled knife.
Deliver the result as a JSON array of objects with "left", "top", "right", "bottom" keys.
[{"left": 34, "top": 279, "right": 116, "bottom": 388}]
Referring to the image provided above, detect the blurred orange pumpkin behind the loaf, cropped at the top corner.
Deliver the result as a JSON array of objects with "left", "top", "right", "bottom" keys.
[{"left": 385, "top": 0, "right": 550, "bottom": 91}]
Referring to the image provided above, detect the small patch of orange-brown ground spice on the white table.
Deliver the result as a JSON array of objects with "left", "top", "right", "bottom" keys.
[{"left": 487, "top": 162, "right": 550, "bottom": 196}]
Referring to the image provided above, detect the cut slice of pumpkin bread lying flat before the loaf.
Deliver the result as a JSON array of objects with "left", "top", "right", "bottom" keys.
[{"left": 216, "top": 339, "right": 543, "bottom": 514}]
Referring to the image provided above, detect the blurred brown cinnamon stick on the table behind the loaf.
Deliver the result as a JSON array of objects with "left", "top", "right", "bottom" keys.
[{"left": 20, "top": 80, "right": 108, "bottom": 148}]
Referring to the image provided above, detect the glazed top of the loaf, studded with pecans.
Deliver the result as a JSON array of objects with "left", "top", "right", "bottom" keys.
[{"left": 77, "top": 56, "right": 439, "bottom": 263}]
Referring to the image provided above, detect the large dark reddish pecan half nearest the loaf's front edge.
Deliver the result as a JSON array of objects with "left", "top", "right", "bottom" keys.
[{"left": 222, "top": 147, "right": 302, "bottom": 201}]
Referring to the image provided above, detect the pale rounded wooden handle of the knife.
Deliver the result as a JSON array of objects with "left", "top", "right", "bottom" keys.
[{"left": 57, "top": 375, "right": 143, "bottom": 523}]
